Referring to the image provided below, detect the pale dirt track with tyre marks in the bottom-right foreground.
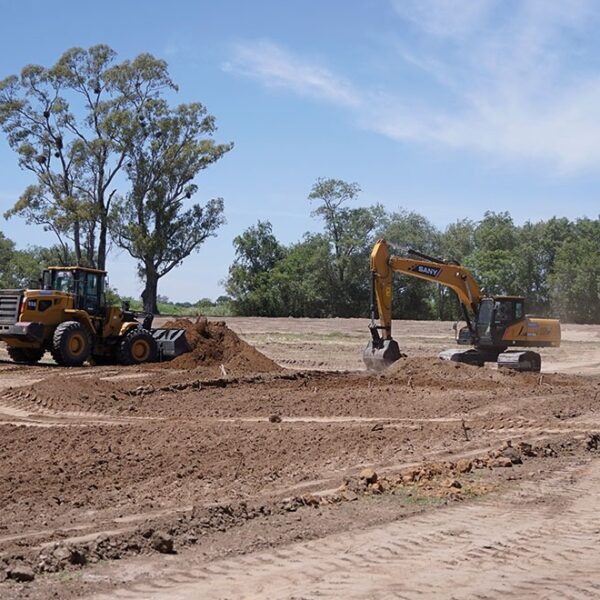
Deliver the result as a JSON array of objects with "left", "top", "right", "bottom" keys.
[{"left": 88, "top": 460, "right": 600, "bottom": 600}]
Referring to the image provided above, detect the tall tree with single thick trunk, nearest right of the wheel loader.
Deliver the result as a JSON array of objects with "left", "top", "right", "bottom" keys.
[{"left": 111, "top": 100, "right": 233, "bottom": 313}]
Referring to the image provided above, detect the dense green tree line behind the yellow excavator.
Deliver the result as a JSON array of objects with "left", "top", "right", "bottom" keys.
[{"left": 225, "top": 179, "right": 600, "bottom": 323}]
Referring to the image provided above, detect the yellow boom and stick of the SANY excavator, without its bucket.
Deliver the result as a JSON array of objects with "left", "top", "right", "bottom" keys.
[{"left": 370, "top": 240, "right": 483, "bottom": 339}]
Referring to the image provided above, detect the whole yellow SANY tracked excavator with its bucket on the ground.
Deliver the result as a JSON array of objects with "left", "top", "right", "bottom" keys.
[{"left": 363, "top": 239, "right": 560, "bottom": 371}]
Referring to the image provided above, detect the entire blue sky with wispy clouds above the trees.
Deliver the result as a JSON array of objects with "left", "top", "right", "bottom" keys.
[{"left": 0, "top": 0, "right": 600, "bottom": 301}]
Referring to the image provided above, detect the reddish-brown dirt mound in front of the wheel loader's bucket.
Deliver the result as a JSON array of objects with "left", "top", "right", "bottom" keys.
[{"left": 163, "top": 317, "right": 282, "bottom": 375}]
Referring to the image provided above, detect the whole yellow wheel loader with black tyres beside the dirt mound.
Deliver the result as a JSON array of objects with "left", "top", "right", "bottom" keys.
[{"left": 0, "top": 267, "right": 190, "bottom": 367}]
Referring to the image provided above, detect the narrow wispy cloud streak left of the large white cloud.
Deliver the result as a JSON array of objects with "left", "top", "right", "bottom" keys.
[{"left": 224, "top": 40, "right": 361, "bottom": 107}]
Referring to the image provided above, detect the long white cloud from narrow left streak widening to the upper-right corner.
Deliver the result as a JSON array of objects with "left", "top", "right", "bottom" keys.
[{"left": 227, "top": 0, "right": 600, "bottom": 173}]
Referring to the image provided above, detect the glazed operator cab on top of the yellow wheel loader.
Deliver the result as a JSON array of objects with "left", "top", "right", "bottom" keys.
[{"left": 42, "top": 267, "right": 106, "bottom": 315}]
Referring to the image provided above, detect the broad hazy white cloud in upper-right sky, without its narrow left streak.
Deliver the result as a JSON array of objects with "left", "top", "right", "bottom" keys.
[{"left": 382, "top": 0, "right": 600, "bottom": 172}]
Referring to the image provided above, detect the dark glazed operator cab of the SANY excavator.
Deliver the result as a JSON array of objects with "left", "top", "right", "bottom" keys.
[{"left": 477, "top": 296, "right": 525, "bottom": 347}]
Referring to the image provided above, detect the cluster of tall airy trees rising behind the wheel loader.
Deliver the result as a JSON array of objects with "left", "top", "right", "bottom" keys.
[{"left": 0, "top": 45, "right": 232, "bottom": 310}]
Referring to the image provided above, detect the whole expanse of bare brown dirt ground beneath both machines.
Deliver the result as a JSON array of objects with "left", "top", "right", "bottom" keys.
[{"left": 0, "top": 319, "right": 600, "bottom": 600}]
